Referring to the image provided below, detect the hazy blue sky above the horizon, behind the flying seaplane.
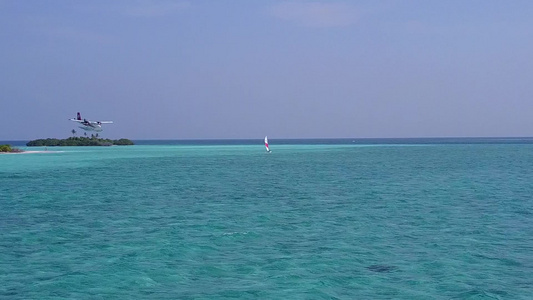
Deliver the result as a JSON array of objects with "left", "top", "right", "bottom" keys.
[{"left": 0, "top": 0, "right": 533, "bottom": 140}]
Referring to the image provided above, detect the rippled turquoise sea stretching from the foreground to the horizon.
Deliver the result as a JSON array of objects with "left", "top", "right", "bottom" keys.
[{"left": 0, "top": 139, "right": 533, "bottom": 299}]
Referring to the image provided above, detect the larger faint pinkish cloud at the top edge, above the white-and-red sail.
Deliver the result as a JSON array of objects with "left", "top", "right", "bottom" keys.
[{"left": 270, "top": 1, "right": 359, "bottom": 27}]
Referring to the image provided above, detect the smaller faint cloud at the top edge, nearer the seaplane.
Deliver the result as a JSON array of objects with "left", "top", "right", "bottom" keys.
[{"left": 123, "top": 0, "right": 190, "bottom": 18}]
